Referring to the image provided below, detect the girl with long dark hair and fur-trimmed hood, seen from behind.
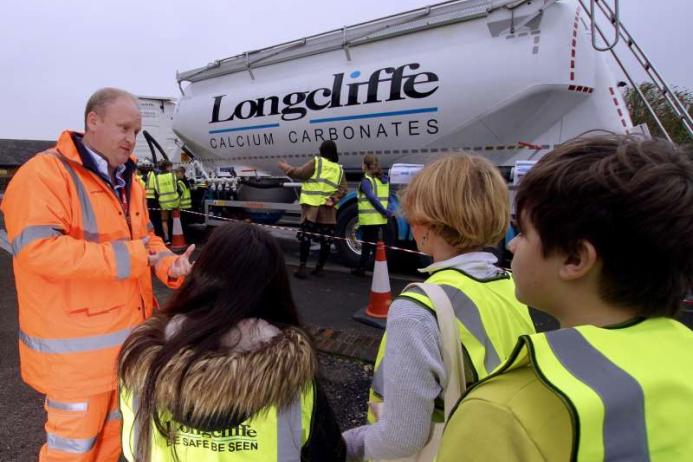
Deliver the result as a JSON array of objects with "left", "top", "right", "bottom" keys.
[{"left": 119, "top": 224, "right": 345, "bottom": 462}]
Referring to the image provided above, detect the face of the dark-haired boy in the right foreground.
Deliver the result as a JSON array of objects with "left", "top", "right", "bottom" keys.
[{"left": 509, "top": 217, "right": 562, "bottom": 313}]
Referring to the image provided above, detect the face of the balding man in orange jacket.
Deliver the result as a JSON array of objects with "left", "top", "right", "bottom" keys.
[{"left": 87, "top": 97, "right": 142, "bottom": 168}]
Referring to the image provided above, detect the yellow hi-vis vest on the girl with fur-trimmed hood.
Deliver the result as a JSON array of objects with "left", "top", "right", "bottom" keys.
[{"left": 120, "top": 385, "right": 315, "bottom": 462}]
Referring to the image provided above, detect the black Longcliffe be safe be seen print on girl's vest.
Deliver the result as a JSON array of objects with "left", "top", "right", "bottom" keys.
[{"left": 165, "top": 422, "right": 258, "bottom": 452}]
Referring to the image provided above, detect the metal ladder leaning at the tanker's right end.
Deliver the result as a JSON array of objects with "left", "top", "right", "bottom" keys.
[{"left": 578, "top": 0, "right": 693, "bottom": 141}]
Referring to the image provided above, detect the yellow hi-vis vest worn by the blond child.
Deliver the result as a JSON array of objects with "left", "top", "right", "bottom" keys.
[{"left": 368, "top": 268, "right": 535, "bottom": 423}]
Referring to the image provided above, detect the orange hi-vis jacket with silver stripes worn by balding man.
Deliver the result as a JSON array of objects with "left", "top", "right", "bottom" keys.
[{"left": 2, "top": 131, "right": 183, "bottom": 397}]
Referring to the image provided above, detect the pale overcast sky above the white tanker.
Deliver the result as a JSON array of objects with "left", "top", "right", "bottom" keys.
[{"left": 0, "top": 0, "right": 693, "bottom": 139}]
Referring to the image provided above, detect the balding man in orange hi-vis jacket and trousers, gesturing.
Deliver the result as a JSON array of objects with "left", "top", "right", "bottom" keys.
[{"left": 2, "top": 88, "right": 194, "bottom": 461}]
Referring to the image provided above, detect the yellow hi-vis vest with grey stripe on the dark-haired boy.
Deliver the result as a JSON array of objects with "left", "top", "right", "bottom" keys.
[{"left": 451, "top": 318, "right": 693, "bottom": 462}]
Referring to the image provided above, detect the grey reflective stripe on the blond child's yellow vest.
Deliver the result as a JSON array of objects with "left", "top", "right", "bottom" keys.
[{"left": 407, "top": 284, "right": 500, "bottom": 373}]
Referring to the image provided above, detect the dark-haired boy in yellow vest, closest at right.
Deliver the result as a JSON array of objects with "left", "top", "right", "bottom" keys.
[{"left": 437, "top": 135, "right": 693, "bottom": 462}]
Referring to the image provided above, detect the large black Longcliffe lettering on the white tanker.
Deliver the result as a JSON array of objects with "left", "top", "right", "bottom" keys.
[{"left": 209, "top": 63, "right": 438, "bottom": 124}]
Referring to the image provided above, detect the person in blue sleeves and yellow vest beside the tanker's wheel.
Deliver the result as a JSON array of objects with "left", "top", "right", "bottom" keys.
[{"left": 351, "top": 154, "right": 392, "bottom": 276}]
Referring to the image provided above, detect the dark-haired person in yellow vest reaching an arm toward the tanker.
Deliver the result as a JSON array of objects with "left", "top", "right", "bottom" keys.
[{"left": 279, "top": 140, "right": 348, "bottom": 279}]
